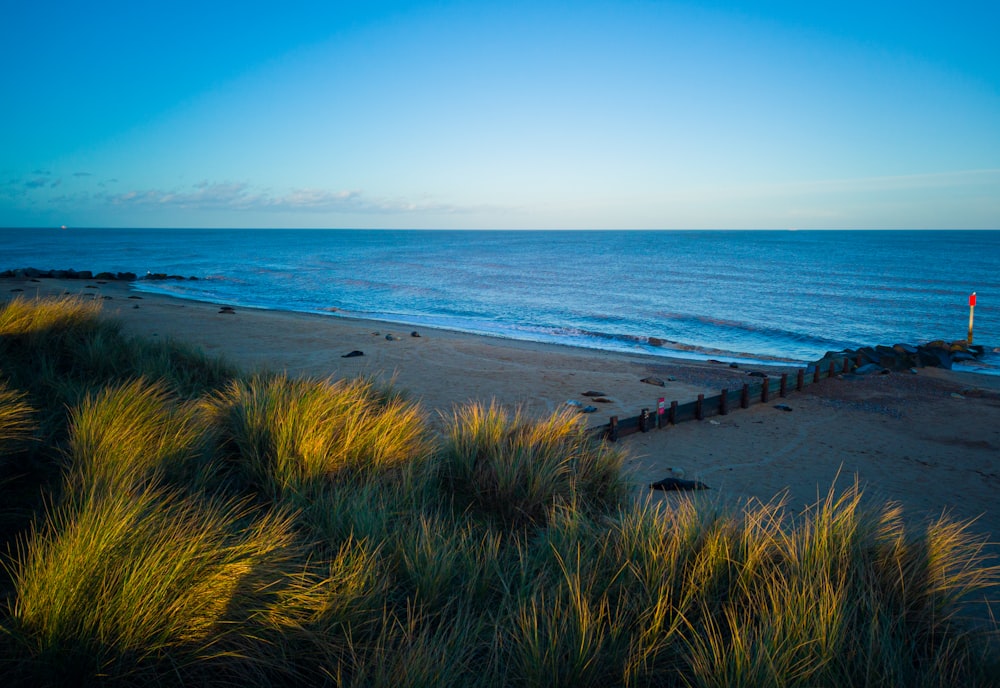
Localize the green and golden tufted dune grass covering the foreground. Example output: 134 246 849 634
0 299 1000 688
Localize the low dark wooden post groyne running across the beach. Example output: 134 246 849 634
593 355 860 442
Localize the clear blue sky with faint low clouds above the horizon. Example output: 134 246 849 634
0 0 1000 229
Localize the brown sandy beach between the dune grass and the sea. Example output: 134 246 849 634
7 279 1000 539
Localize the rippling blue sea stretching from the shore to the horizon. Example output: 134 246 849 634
0 228 1000 374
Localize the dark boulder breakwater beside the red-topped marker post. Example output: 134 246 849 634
816 339 985 372
